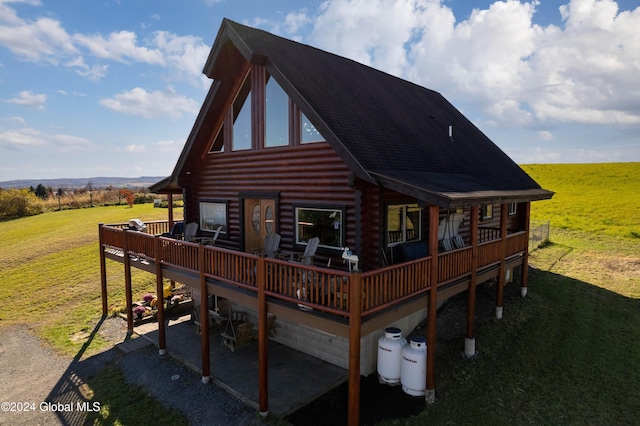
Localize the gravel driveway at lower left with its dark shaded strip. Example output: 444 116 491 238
0 318 266 425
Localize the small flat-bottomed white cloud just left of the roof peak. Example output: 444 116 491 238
100 87 200 119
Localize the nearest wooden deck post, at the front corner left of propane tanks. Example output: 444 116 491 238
348 272 362 426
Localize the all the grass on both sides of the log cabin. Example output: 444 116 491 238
0 163 640 424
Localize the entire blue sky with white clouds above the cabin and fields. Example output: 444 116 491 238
0 0 640 181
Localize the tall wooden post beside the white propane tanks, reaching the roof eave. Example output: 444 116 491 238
425 205 440 404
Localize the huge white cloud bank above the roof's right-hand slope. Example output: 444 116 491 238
311 0 640 130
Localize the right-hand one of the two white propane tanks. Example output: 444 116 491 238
400 336 427 396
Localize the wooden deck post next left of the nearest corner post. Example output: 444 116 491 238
256 256 269 417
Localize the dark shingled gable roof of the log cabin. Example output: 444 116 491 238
176 19 552 207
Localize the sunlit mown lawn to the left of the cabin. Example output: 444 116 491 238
0 204 180 355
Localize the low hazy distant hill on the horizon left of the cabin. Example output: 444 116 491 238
0 176 166 190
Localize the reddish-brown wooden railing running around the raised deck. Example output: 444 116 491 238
100 222 528 317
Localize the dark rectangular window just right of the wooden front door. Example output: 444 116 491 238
295 207 344 249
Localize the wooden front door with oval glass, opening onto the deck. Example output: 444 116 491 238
244 198 276 253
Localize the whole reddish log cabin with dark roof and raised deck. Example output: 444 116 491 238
99 19 553 424
